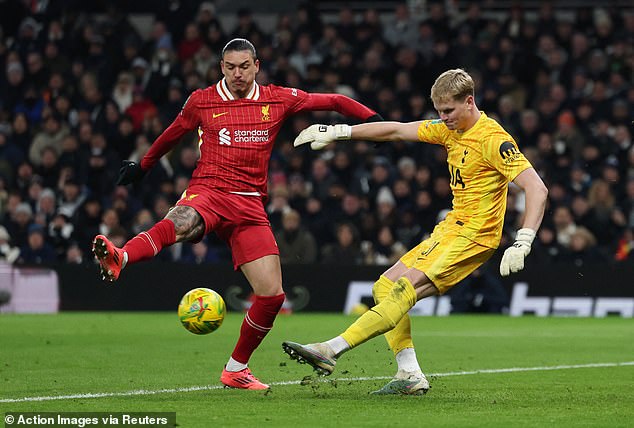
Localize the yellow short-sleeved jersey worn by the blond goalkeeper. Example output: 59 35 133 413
418 112 532 248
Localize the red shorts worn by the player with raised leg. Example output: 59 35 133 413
176 184 280 270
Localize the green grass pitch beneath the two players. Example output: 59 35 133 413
0 312 634 427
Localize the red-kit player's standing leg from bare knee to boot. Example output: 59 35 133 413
220 254 284 389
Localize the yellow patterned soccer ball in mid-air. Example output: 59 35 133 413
178 288 225 334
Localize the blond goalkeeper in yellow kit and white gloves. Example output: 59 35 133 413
282 69 548 394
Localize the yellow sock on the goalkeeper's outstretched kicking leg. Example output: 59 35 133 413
341 278 416 348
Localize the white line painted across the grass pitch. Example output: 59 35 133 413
0 361 634 403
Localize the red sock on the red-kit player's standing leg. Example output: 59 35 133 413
231 293 286 364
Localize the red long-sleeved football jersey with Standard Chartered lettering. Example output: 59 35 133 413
141 79 375 195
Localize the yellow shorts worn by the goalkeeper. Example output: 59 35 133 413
400 221 495 294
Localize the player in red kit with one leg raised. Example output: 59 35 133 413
93 39 381 389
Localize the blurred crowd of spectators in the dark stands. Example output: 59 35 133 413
0 0 634 265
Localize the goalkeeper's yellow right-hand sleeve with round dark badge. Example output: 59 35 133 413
482 133 532 181
